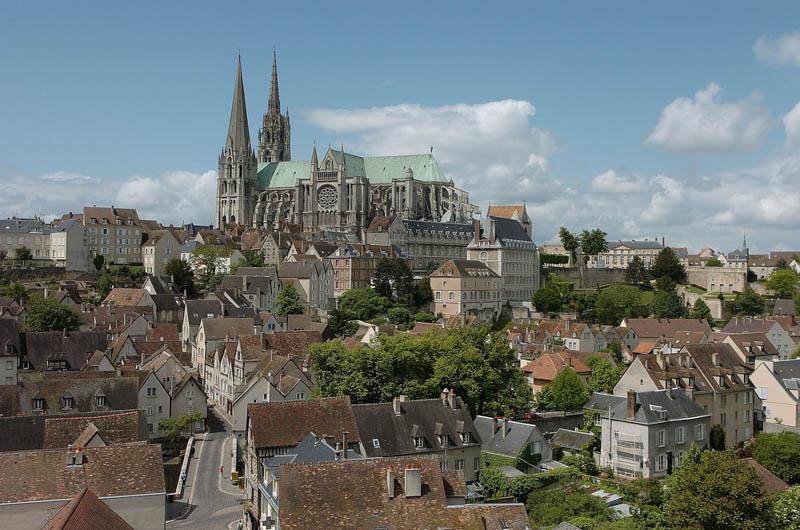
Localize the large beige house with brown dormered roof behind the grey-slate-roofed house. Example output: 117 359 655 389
614 343 756 445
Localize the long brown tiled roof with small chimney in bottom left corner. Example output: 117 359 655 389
0 443 165 503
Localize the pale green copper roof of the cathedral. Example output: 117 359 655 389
258 150 450 189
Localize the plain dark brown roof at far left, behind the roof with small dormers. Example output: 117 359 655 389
21 331 108 370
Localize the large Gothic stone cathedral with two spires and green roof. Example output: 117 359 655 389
216 52 479 237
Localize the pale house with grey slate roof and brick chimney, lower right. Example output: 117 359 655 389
586 387 711 478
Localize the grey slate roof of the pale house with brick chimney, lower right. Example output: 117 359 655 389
585 389 710 425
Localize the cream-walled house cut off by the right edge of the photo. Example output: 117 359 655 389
750 359 800 430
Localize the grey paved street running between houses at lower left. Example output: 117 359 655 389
167 409 242 530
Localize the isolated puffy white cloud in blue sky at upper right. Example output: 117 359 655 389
645 83 770 153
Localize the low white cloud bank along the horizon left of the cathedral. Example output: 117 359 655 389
0 171 217 224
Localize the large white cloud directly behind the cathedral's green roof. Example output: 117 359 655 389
305 99 556 201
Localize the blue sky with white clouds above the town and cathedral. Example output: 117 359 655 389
0 1 800 252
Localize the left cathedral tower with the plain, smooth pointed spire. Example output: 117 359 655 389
216 57 258 228
